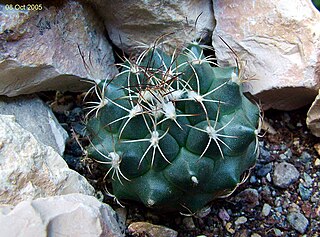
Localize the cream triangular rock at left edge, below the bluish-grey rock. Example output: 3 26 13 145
0 115 94 205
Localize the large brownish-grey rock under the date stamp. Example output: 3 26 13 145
0 0 116 96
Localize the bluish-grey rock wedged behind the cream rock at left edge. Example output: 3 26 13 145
0 95 68 156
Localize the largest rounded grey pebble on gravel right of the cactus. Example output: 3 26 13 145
272 162 300 188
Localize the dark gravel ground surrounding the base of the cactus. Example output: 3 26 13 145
45 94 320 237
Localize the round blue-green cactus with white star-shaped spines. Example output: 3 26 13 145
87 43 259 212
